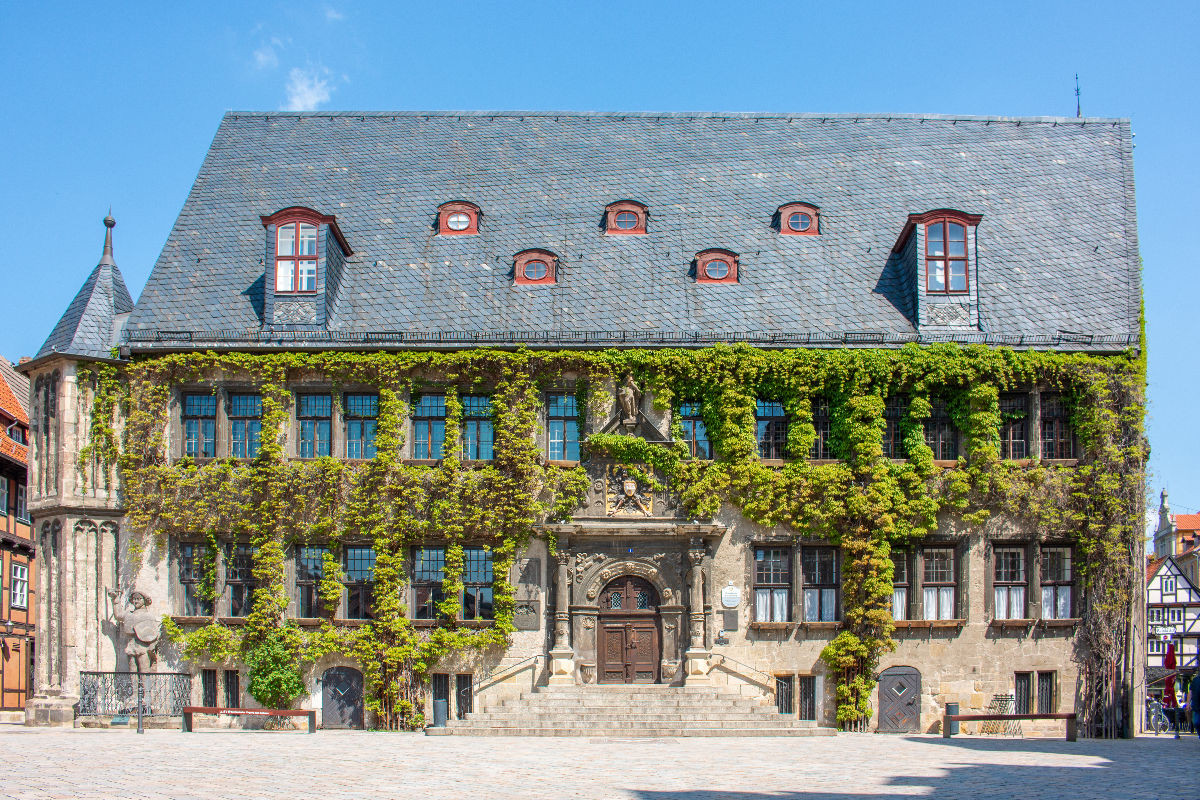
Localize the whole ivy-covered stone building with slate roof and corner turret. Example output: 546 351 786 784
18 114 1146 735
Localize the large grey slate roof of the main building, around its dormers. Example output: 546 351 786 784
121 113 1141 350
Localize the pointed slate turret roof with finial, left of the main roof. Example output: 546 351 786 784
35 217 133 360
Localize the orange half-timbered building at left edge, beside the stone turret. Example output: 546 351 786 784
0 359 37 718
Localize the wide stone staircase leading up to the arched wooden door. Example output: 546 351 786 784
425 685 834 738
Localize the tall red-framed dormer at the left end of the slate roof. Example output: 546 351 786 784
260 206 354 330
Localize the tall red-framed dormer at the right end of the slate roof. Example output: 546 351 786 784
892 209 983 333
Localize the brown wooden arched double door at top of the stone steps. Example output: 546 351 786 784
596 575 662 684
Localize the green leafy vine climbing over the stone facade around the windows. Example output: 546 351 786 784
79 344 1146 728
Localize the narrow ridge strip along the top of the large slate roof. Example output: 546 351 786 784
224 109 1130 125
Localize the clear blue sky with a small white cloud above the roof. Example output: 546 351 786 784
0 0 1200 522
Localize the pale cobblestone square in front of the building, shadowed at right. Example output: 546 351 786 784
0 726 1200 800
